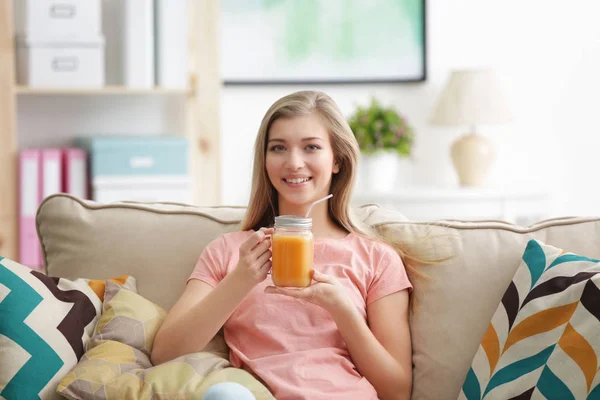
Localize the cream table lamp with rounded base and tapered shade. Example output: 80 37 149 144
431 69 510 186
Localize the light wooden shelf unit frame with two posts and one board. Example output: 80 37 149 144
0 0 222 260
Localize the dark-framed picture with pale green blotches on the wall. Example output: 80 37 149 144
220 0 426 84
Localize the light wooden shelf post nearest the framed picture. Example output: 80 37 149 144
186 0 221 206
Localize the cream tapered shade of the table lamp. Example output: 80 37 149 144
431 69 511 126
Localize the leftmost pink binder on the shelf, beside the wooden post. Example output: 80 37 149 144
19 150 42 269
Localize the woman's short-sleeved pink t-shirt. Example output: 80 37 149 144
190 231 412 400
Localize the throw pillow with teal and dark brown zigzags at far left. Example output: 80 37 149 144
0 257 135 400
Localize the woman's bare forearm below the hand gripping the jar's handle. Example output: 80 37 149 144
152 273 252 364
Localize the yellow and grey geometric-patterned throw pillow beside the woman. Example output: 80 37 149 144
58 282 274 400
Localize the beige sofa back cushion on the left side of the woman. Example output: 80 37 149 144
37 194 244 309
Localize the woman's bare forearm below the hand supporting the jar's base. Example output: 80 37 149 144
332 304 412 400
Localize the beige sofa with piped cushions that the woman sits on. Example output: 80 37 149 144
37 195 600 400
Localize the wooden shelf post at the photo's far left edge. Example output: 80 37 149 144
0 0 18 260
